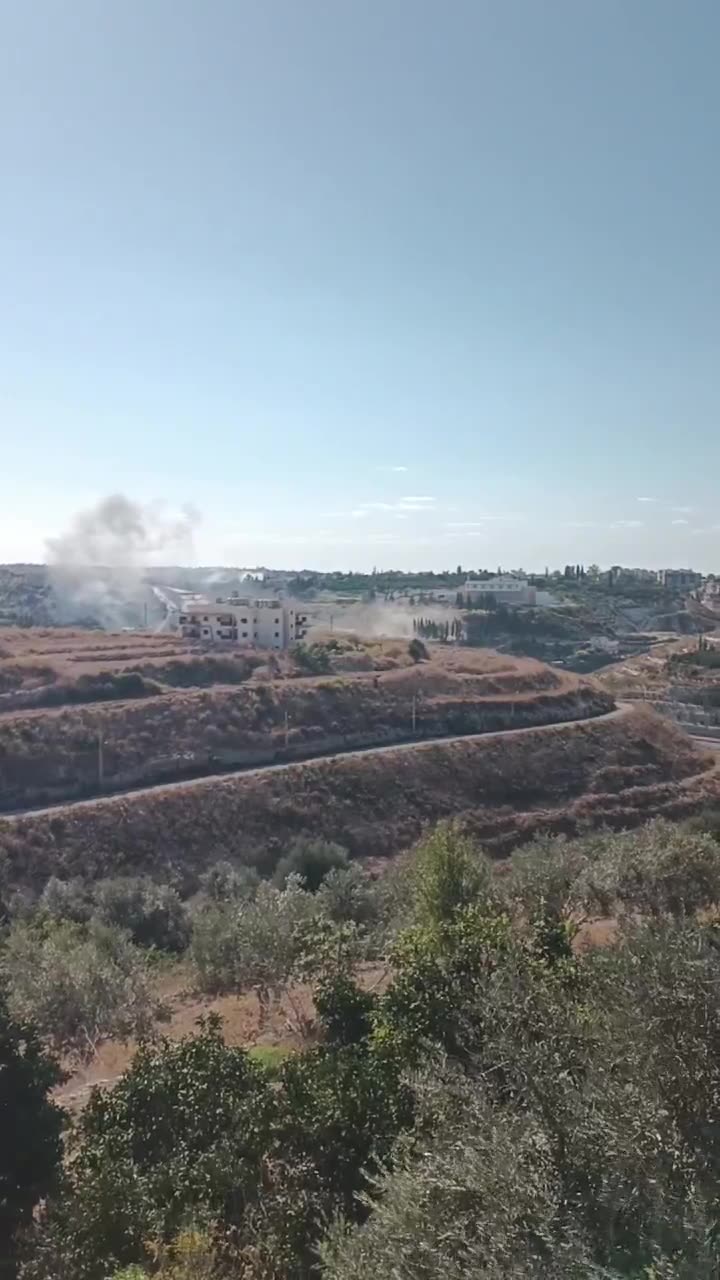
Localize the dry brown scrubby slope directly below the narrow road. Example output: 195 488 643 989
0 708 720 887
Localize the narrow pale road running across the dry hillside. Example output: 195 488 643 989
0 704 634 822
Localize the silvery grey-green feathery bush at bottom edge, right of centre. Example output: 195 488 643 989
323 1080 591 1280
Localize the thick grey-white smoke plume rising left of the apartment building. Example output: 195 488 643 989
46 494 200 630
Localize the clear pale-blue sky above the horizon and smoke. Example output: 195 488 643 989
0 0 720 571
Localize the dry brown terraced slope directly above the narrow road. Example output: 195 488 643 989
0 636 612 810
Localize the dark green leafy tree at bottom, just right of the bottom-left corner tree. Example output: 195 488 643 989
27 1018 277 1280
